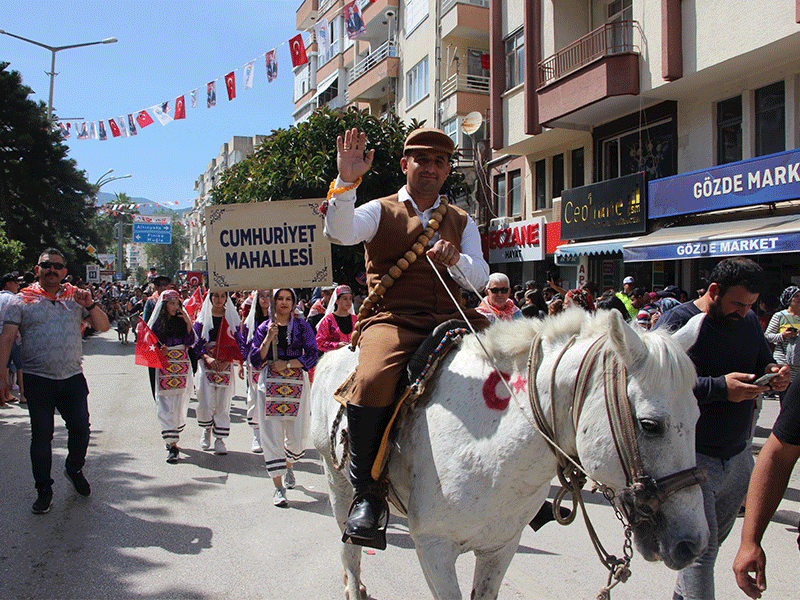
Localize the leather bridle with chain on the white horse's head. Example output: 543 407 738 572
528 334 707 596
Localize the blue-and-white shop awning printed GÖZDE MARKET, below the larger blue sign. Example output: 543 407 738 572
622 215 800 262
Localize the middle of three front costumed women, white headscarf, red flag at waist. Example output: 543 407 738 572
194 292 244 454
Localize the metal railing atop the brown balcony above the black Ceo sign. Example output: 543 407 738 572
539 21 642 88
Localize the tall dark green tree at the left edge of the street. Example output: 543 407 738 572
0 62 97 276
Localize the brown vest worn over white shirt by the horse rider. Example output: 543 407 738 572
364 194 469 314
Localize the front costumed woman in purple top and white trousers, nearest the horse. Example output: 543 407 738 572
249 289 319 506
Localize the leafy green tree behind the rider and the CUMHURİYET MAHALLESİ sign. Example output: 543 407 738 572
211 107 468 284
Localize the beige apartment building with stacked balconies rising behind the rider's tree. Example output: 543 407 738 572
294 0 489 214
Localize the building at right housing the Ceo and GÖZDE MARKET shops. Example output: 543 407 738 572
487 0 800 293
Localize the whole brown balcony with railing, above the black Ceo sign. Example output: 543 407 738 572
537 21 642 126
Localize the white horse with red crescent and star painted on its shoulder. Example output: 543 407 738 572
311 309 708 600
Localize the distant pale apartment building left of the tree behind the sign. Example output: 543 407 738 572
181 135 266 271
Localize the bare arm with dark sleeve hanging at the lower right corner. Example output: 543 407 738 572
733 379 800 598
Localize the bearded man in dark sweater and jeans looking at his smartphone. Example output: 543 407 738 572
654 257 790 600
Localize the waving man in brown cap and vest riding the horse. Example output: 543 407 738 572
325 128 489 547
